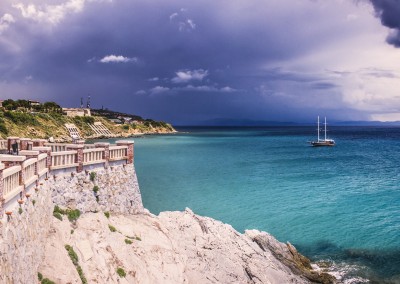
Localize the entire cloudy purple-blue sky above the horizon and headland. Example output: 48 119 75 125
0 0 400 125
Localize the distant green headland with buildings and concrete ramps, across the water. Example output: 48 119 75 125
0 99 176 142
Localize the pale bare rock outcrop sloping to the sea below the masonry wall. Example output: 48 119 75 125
39 209 330 283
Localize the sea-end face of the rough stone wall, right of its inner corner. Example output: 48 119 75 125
48 164 144 214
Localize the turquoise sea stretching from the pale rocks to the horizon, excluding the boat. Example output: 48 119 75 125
130 127 400 283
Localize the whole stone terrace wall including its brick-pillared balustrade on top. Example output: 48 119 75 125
0 137 145 284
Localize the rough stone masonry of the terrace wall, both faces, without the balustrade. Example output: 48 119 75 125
0 164 144 284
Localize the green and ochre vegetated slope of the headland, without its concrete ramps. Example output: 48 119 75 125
0 100 175 141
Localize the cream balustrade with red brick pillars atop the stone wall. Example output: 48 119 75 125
0 137 133 219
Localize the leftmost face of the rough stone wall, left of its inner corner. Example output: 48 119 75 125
0 181 54 284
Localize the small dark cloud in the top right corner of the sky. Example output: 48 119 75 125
370 0 400 47
